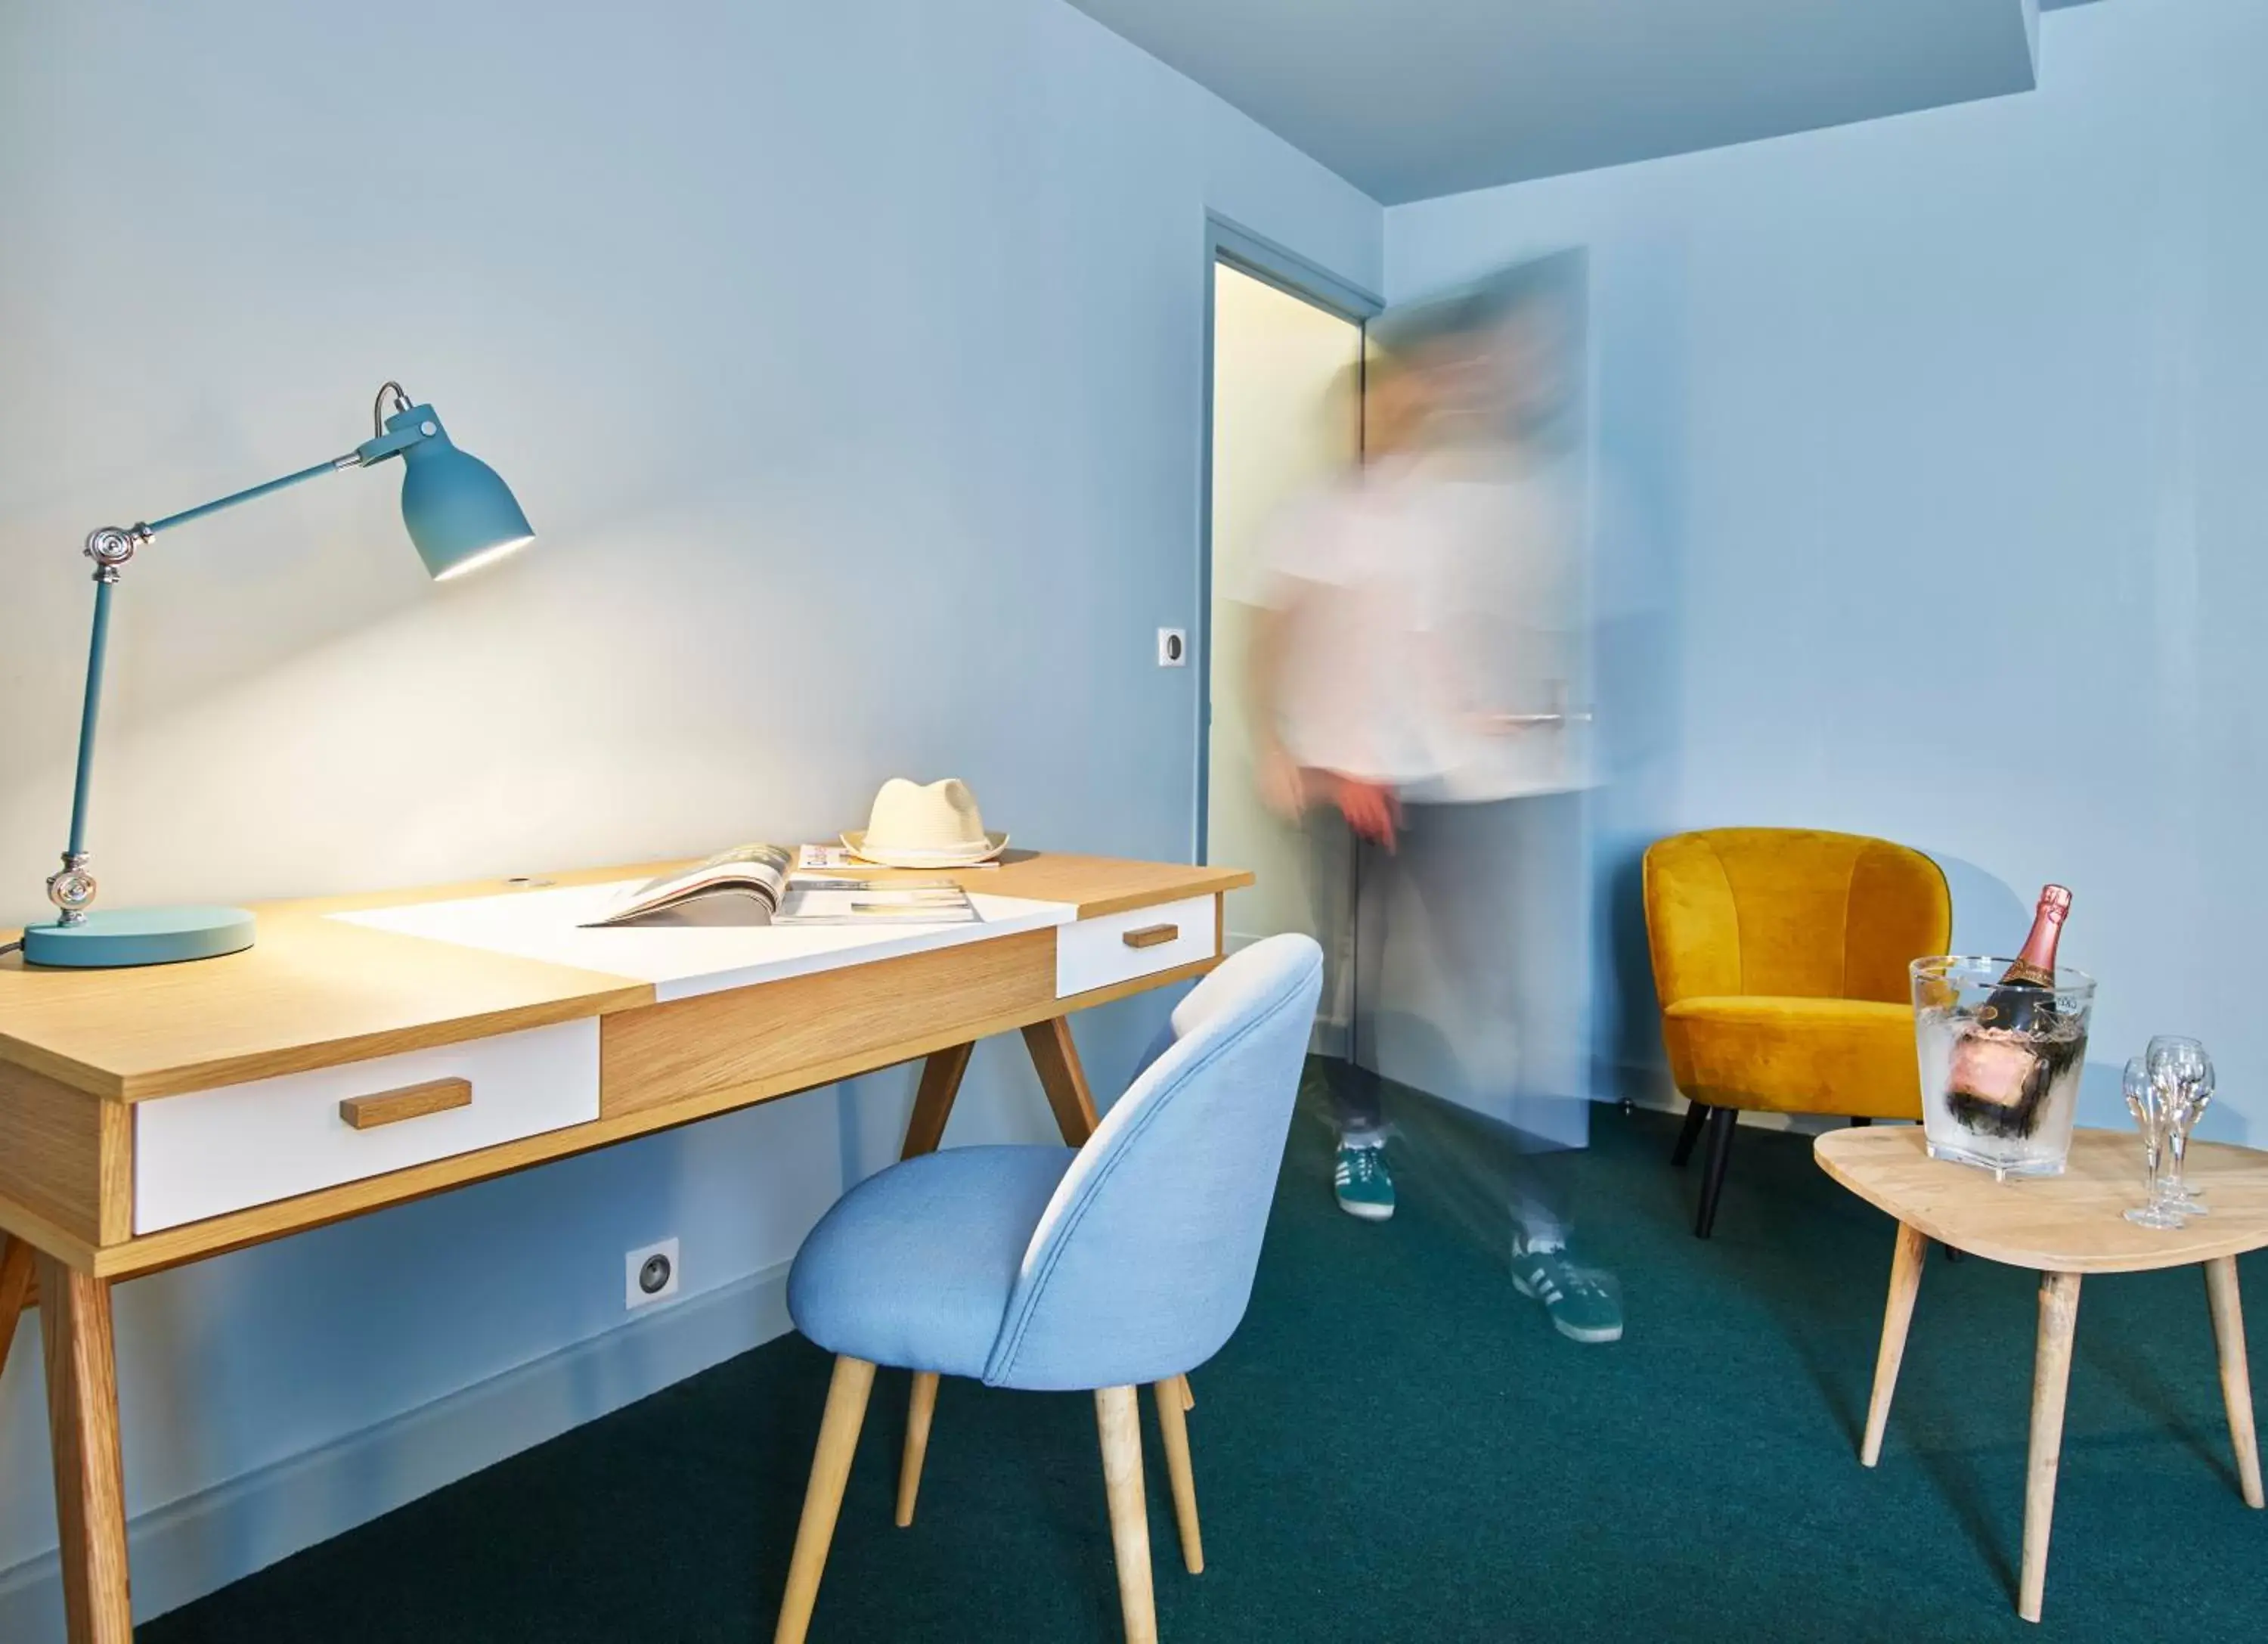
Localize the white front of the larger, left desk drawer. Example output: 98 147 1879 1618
134 1018 599 1233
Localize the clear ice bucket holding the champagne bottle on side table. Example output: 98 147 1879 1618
1910 954 2096 1179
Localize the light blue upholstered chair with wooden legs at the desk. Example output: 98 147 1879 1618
773 936 1322 1644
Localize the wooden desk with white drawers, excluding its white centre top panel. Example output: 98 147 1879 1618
0 852 1252 1644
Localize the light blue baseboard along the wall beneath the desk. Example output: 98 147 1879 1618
0 1261 789 1639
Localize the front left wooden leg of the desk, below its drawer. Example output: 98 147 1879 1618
39 1256 134 1644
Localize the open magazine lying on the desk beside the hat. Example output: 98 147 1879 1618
583 845 978 929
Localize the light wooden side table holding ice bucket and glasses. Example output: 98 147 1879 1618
1812 1127 2268 1621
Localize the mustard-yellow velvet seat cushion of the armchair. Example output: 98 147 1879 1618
1662 995 1921 1118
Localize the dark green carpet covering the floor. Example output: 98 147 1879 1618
141 1084 2268 1644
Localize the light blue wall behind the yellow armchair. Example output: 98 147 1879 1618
1388 0 2268 1138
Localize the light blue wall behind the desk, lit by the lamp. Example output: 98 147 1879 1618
0 0 1381 1637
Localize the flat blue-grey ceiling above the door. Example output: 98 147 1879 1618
1070 0 2082 204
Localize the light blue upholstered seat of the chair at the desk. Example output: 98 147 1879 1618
787 1147 1077 1376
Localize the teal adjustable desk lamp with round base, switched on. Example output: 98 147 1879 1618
23 383 535 968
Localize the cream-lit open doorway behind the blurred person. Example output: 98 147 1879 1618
1198 225 1377 1056
